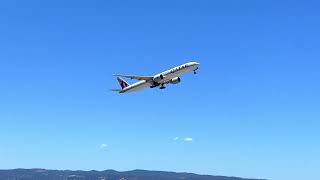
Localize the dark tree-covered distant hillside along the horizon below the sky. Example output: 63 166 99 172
0 169 264 180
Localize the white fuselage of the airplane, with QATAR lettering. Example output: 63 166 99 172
120 62 200 93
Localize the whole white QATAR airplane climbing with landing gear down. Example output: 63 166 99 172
112 62 200 93
